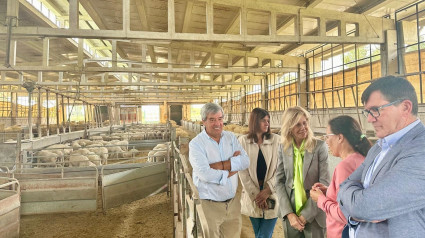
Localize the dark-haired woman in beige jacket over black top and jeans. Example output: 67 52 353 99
238 108 280 237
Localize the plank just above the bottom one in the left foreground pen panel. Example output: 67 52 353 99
21 187 97 203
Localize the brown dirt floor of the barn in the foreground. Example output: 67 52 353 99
20 193 283 238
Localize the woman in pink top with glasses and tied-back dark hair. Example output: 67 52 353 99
310 116 372 238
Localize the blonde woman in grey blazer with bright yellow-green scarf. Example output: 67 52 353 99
276 106 329 238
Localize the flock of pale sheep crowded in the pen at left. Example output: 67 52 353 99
30 130 169 167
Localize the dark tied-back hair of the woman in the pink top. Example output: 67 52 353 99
328 116 372 156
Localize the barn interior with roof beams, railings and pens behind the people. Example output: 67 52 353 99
0 0 425 237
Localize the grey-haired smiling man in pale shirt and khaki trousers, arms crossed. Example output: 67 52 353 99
189 103 249 238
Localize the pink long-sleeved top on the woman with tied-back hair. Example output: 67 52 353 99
317 153 364 238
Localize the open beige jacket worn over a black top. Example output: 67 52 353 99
238 134 281 219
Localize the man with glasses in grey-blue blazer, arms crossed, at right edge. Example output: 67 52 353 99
338 76 425 238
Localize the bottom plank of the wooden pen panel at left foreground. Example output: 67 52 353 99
21 200 97 215
